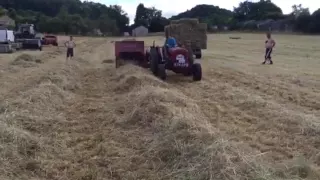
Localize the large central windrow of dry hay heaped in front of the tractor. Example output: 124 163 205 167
96 65 318 180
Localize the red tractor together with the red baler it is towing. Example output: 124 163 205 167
115 39 202 81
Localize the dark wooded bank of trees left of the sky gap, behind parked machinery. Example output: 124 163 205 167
0 0 129 34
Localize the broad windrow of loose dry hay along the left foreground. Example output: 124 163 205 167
0 63 80 179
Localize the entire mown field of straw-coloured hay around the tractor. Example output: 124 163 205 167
0 34 320 180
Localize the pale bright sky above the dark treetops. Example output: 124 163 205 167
87 0 320 23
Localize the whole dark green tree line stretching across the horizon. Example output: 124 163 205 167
0 0 320 35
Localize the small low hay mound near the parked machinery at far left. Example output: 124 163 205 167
11 54 43 68
